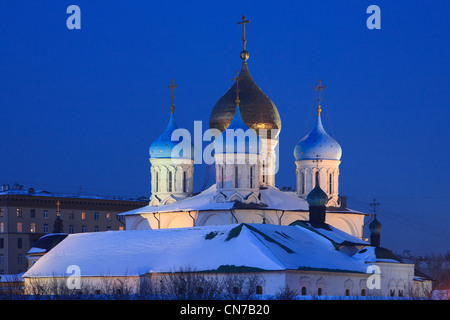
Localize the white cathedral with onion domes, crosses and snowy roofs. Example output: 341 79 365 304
23 16 431 297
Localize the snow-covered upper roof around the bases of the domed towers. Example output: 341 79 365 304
121 184 363 215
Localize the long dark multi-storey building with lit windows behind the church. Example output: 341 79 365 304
0 184 148 275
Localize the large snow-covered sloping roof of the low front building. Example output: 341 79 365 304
24 224 374 277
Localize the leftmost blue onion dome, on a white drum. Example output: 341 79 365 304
149 112 194 159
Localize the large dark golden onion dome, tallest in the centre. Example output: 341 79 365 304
209 61 281 138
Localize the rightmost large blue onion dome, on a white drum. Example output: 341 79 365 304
294 115 342 161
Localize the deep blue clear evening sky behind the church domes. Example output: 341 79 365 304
0 0 450 254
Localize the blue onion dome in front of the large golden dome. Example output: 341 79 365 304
214 106 261 154
